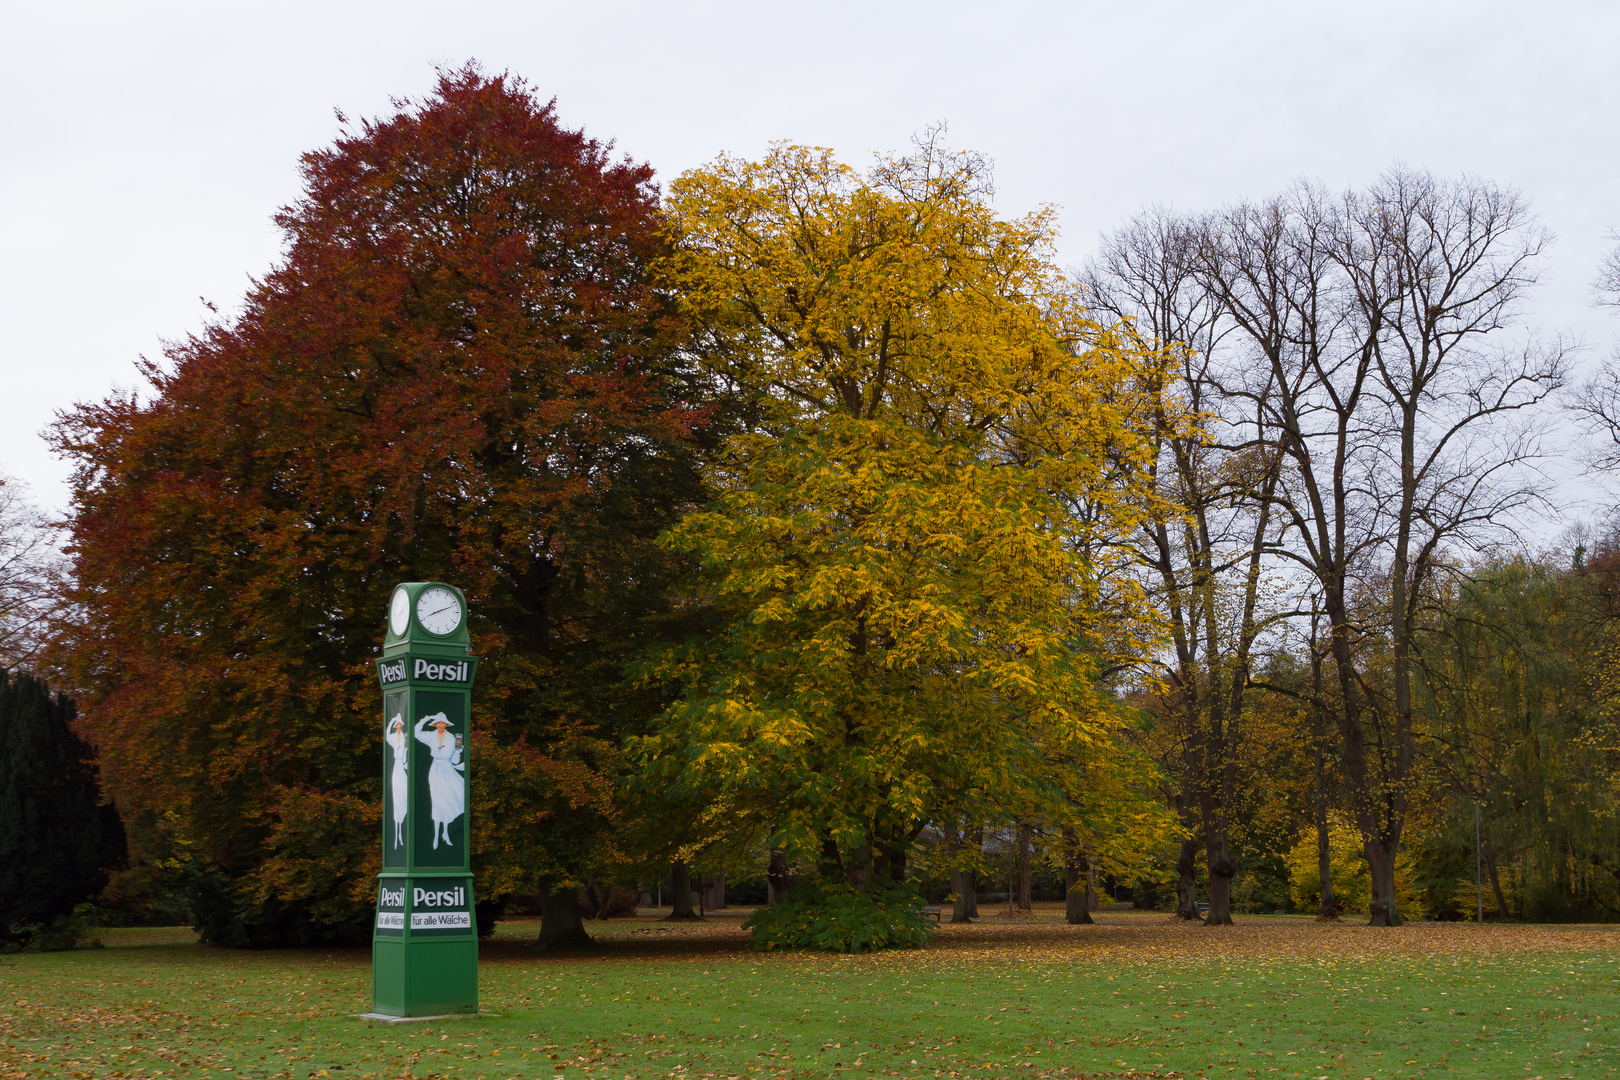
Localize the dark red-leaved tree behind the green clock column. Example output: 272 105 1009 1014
57 66 703 942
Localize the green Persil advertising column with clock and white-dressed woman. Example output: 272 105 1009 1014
371 581 478 1018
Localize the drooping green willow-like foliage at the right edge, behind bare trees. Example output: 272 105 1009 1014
1419 549 1620 920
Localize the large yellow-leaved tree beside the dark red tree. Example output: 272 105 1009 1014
638 139 1165 945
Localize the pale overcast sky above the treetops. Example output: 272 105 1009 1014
0 0 1620 510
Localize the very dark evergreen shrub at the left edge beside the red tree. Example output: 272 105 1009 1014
0 669 123 946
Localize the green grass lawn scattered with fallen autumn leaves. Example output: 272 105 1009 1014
0 905 1620 1080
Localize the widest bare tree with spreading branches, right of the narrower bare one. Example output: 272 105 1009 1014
1202 168 1565 926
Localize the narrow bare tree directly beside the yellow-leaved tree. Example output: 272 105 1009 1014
1081 210 1280 925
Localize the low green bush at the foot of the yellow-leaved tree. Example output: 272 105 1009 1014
744 884 935 952
